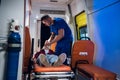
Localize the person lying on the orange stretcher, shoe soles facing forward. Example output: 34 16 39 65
33 46 66 67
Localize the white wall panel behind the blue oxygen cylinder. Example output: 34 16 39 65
0 0 24 80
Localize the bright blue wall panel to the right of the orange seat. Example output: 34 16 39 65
90 0 120 74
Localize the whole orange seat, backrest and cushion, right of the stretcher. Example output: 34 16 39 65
72 40 116 80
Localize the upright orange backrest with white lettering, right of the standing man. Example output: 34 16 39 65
71 40 94 69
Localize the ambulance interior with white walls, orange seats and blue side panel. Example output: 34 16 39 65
0 0 120 80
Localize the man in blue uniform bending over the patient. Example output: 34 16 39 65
41 15 73 65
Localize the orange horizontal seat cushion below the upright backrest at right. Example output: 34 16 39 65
77 64 116 80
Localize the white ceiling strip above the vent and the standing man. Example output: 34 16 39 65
31 0 72 10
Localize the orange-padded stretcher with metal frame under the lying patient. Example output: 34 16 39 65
33 50 74 80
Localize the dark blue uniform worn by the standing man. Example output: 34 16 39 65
50 18 73 57
